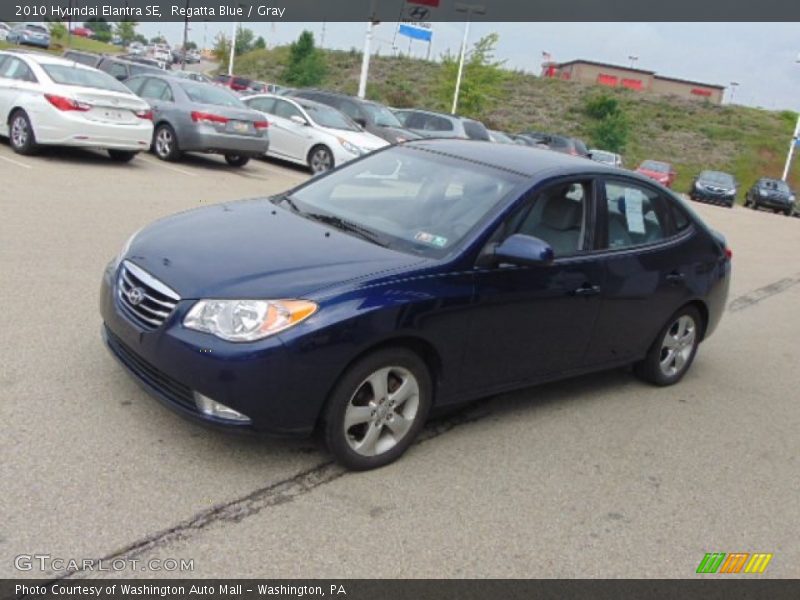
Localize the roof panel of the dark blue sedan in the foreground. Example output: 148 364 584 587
403 138 624 181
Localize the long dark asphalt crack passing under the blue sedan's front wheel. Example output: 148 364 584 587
47 398 491 585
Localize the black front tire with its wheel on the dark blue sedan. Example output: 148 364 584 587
321 348 433 471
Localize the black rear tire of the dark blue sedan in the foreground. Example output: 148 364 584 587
633 306 705 386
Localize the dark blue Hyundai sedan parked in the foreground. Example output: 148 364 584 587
101 140 731 469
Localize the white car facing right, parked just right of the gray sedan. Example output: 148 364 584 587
242 94 389 175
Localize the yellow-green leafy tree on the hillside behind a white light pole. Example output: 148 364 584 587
435 33 507 118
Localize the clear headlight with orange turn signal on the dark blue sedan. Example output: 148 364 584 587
183 300 317 342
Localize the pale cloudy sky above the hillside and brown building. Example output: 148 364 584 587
139 22 800 111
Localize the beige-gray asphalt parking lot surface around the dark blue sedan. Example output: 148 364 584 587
0 141 800 578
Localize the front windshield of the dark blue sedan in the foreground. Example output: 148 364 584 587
284 146 521 257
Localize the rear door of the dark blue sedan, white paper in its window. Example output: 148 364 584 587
587 177 706 366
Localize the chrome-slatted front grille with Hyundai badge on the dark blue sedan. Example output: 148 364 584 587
117 260 181 329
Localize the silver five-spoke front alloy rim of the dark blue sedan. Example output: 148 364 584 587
344 366 420 456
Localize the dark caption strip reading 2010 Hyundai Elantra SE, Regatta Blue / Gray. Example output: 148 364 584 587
0 0 800 22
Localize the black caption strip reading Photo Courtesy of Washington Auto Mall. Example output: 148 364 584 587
0 575 800 600
